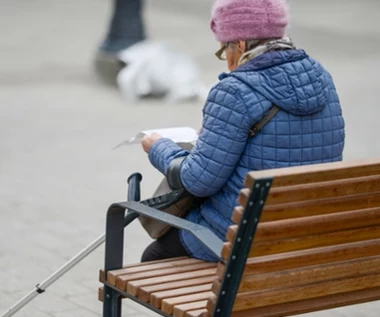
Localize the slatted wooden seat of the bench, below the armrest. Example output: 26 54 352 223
99 257 217 317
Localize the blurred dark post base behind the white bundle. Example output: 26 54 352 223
95 0 145 85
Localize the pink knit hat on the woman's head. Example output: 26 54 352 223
211 0 288 42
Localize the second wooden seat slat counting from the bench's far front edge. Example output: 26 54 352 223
116 260 215 290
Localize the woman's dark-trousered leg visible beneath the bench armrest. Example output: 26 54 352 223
141 229 189 262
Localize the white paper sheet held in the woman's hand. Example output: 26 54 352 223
113 127 198 150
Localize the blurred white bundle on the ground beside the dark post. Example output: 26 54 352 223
117 41 208 102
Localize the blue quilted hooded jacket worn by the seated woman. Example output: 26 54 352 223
149 50 345 261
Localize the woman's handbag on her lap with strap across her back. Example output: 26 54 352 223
139 105 280 239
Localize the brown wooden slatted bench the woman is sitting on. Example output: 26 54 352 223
99 160 380 317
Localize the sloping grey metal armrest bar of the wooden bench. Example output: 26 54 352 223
114 201 224 259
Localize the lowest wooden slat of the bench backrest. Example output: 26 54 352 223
229 288 380 317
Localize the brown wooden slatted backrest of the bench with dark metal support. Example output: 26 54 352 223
207 160 380 317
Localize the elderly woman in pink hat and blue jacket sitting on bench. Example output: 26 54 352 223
142 0 345 261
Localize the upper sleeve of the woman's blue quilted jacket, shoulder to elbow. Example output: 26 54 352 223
181 82 251 197
